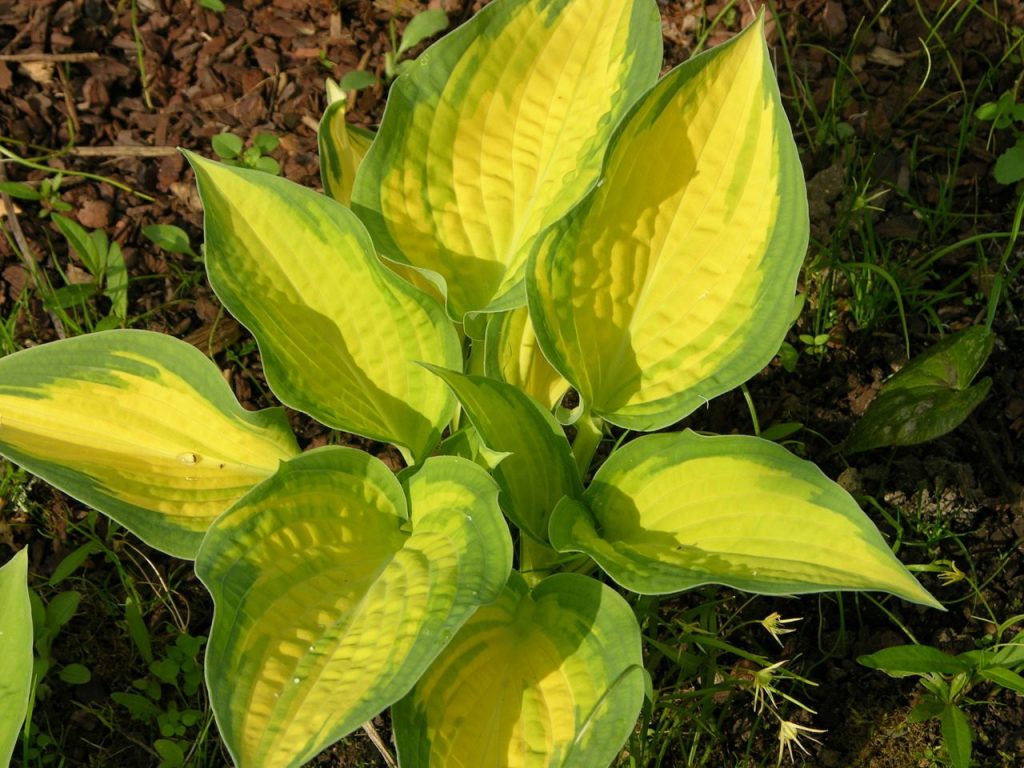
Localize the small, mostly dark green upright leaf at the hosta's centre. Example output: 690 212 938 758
430 367 583 543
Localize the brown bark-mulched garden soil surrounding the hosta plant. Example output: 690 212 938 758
0 0 1024 768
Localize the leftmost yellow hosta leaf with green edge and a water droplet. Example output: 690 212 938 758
0 331 299 558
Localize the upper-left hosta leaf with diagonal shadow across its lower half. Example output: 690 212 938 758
187 154 462 462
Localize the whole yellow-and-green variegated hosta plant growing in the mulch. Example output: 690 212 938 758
0 0 936 768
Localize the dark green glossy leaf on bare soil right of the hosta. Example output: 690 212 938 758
843 326 995 454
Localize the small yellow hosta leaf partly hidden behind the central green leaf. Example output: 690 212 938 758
483 307 569 411
